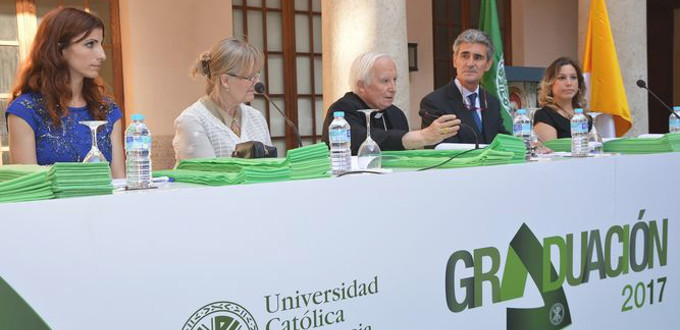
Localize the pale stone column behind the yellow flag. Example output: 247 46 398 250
578 0 649 136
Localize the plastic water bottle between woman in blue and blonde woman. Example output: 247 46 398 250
125 114 151 189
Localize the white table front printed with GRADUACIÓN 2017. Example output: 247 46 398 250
0 153 680 330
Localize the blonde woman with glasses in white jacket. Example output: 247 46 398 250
172 38 272 161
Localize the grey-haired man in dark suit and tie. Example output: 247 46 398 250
419 29 509 144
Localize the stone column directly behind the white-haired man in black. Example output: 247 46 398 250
321 0 417 117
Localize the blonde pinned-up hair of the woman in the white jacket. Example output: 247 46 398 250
191 37 264 95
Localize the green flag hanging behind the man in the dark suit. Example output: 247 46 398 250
479 0 512 133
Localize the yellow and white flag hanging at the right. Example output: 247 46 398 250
583 0 633 137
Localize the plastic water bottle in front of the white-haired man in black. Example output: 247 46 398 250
328 111 352 175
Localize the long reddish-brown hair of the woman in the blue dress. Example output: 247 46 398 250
12 8 110 127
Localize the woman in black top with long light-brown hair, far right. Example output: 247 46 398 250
534 57 592 142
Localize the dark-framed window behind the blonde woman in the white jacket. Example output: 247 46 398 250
232 0 324 155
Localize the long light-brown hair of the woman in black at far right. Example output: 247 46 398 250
538 57 587 111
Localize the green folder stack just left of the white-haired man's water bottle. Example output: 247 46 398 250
286 142 331 180
